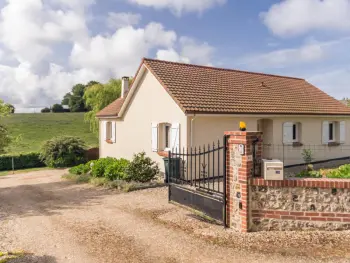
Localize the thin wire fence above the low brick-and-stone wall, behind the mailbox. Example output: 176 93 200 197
262 144 350 166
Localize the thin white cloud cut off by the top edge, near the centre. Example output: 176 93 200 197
128 0 226 16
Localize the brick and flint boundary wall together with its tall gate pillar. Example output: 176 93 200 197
225 131 350 232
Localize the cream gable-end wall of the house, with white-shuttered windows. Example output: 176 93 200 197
100 71 187 171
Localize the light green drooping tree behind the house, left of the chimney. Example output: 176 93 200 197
84 79 121 133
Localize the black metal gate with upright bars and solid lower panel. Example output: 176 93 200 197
168 137 226 227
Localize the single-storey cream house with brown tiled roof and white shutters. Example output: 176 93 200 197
97 59 350 167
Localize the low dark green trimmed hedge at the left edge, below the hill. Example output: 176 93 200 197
0 152 45 171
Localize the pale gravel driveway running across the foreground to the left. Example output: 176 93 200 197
0 170 350 263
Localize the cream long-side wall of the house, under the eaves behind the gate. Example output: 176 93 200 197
188 115 350 165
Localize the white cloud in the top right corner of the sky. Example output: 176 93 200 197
261 0 350 36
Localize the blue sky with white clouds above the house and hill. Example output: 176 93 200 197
0 0 350 112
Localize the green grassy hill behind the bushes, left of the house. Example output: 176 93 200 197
0 113 98 153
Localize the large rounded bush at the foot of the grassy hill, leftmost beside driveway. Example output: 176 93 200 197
40 136 86 168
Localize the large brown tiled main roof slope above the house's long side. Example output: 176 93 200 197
95 59 350 118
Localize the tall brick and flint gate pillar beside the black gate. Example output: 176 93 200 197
225 131 262 232
